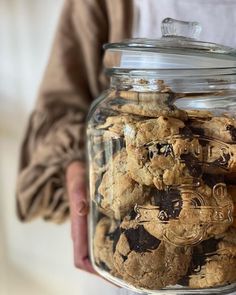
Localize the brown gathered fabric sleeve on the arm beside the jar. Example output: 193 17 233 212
16 0 108 223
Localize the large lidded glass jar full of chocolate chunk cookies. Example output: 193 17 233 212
87 18 236 294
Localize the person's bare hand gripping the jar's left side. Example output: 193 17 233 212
66 162 95 273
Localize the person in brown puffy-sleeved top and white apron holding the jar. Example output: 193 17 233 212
17 0 236 294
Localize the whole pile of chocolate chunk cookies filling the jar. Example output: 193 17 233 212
88 88 236 290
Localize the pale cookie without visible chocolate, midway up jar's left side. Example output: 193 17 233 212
98 149 149 219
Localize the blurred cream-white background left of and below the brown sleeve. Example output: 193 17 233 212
0 0 119 295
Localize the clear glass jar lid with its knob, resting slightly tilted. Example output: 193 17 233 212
104 18 236 70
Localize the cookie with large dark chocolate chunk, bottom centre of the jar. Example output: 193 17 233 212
114 225 191 290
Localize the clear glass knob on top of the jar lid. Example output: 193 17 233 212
161 17 202 39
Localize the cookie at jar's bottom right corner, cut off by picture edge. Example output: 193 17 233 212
182 228 236 288
